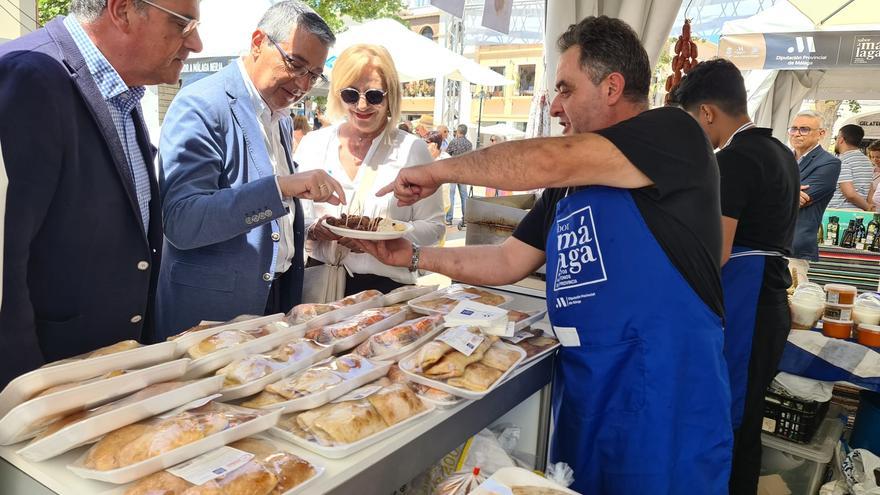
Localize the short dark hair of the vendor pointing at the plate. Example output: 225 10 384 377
556 15 651 103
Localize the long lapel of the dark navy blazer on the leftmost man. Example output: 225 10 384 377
46 18 144 234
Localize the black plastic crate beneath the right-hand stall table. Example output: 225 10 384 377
762 387 830 443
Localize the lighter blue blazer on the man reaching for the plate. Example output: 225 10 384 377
157 63 303 337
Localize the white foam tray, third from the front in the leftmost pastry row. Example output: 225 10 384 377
18 376 223 462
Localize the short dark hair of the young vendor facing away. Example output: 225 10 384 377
672 58 748 116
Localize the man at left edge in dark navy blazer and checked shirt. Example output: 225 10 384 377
0 0 202 386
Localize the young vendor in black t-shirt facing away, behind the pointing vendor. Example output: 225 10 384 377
675 59 800 495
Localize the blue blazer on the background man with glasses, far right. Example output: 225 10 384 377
792 146 840 261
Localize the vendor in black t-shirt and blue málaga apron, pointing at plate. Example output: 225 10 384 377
361 17 733 495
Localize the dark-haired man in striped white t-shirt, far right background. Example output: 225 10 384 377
828 124 874 211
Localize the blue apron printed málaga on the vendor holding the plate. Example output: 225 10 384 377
546 187 733 495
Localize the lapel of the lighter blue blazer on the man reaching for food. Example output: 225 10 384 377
223 62 275 181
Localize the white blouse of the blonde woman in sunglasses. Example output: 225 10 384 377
293 124 446 284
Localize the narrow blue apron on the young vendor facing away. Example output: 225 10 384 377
721 246 782 430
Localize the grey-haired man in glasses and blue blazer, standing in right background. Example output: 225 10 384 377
788 111 840 283
